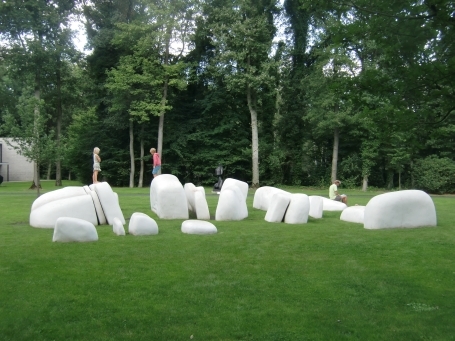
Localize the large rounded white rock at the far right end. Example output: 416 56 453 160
363 190 437 229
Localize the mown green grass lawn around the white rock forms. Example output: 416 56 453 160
0 181 455 341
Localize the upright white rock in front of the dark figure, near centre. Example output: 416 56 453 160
215 185 248 221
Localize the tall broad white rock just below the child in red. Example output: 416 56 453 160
150 174 188 219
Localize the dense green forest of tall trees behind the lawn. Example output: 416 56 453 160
0 0 455 193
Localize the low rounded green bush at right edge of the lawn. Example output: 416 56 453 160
413 155 455 194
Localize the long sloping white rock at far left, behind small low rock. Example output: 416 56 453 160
30 194 98 228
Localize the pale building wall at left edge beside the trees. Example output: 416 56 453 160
0 137 33 182
